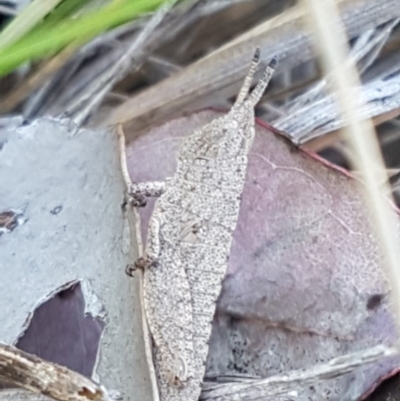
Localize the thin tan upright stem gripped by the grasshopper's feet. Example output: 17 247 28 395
117 124 160 401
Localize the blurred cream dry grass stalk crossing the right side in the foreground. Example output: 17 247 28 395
303 0 400 330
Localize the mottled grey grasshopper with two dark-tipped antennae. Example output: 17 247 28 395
132 52 276 401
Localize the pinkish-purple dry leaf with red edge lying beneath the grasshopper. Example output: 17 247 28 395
128 111 400 401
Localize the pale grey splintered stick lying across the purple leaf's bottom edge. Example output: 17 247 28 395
201 345 398 401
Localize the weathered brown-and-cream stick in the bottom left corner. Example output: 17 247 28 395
0 344 111 401
